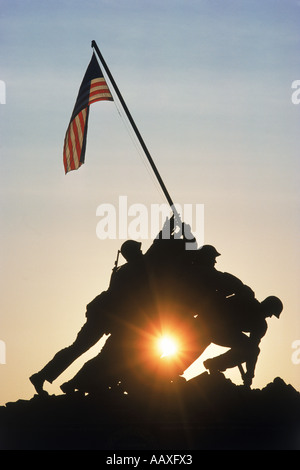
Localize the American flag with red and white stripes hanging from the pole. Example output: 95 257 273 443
63 53 113 173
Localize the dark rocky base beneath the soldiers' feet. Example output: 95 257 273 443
0 372 300 451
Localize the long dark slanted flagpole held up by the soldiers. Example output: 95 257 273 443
92 40 181 223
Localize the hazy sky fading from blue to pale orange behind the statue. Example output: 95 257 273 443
0 0 300 404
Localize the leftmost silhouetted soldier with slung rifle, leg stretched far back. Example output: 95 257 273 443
30 240 148 394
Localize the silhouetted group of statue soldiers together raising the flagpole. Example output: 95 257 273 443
30 219 283 394
